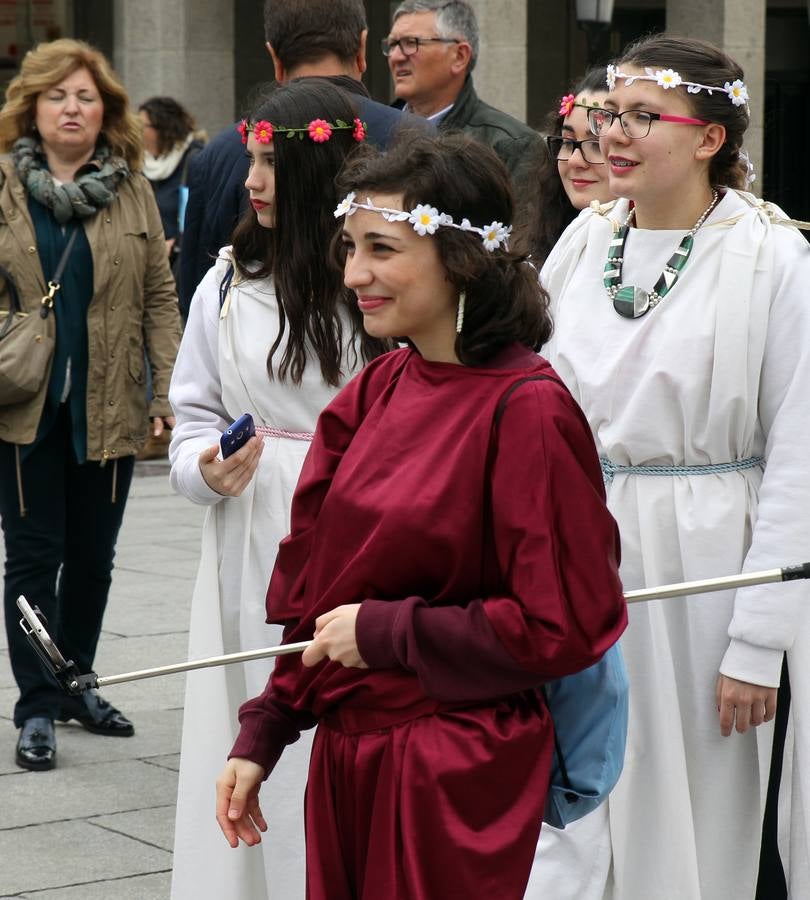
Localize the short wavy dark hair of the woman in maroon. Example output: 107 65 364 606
332 130 551 366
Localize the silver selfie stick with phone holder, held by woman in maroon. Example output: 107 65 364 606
17 562 810 694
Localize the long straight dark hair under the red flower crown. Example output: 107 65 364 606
233 78 390 386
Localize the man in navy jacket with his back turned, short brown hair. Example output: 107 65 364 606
178 0 424 319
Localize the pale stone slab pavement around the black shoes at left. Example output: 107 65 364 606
0 461 204 900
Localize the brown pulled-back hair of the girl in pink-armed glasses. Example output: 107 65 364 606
618 34 750 189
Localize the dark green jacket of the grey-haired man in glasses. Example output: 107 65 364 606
439 75 543 197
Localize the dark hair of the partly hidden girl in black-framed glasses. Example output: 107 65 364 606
517 66 607 265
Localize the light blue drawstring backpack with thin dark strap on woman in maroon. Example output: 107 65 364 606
494 375 629 828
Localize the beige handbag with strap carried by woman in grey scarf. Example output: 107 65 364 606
0 228 78 406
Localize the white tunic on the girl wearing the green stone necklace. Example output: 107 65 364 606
526 191 810 900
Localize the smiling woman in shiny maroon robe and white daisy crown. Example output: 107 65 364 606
217 136 626 900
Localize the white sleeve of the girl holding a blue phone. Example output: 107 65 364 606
169 253 231 506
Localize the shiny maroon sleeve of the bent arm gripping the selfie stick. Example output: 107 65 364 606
357 381 627 701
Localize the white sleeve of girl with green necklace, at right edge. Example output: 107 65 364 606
720 226 810 687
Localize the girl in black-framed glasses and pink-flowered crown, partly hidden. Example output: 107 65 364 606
524 67 615 265
